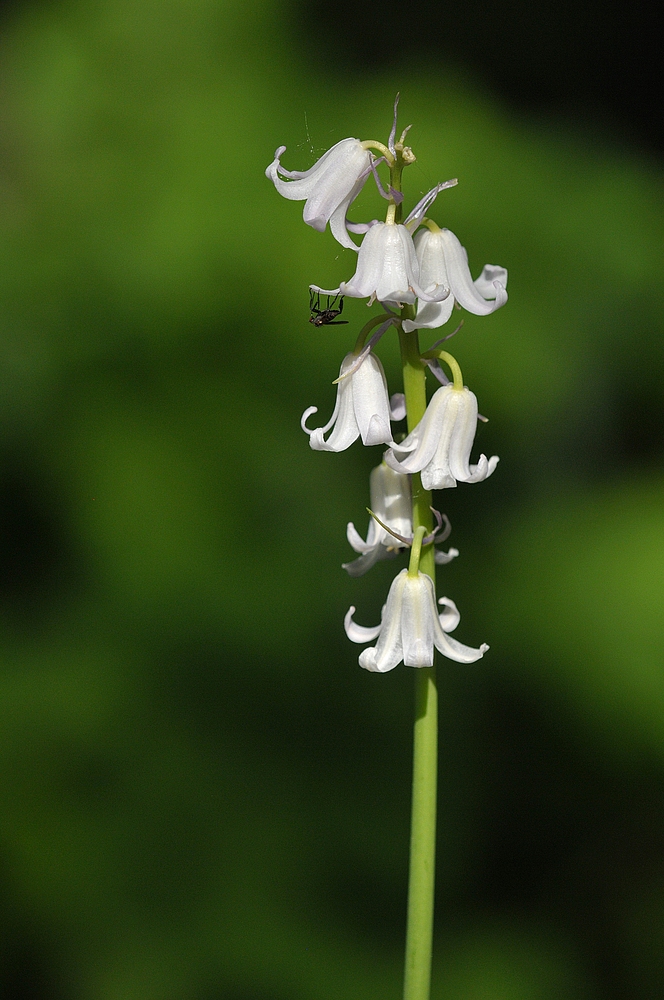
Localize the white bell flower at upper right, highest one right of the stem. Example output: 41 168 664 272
403 227 507 332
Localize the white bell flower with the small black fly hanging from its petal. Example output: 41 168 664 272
336 222 449 305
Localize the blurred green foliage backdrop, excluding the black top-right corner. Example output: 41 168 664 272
0 0 664 1000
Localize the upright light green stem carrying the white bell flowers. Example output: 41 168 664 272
399 318 438 1000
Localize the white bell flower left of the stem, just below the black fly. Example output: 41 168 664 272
300 353 393 451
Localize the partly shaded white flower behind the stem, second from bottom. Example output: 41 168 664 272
343 462 459 576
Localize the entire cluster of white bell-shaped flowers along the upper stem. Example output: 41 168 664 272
266 105 507 673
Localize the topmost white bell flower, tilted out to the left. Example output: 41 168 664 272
265 139 371 251
